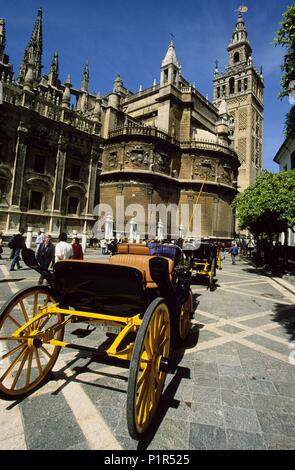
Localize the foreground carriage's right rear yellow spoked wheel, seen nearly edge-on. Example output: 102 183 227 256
127 298 170 439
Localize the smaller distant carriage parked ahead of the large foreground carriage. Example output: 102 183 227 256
183 241 221 291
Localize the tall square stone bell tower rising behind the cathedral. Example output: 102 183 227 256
213 13 264 191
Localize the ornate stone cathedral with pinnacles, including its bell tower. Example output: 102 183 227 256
0 9 263 239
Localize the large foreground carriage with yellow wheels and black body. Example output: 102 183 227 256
0 244 193 439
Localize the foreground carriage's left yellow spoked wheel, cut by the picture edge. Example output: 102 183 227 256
0 286 64 398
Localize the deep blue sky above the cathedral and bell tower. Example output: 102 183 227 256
0 0 292 171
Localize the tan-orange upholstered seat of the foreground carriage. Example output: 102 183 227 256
109 255 174 289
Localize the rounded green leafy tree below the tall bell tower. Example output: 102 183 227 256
232 170 295 239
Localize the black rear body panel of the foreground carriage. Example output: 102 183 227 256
53 260 147 316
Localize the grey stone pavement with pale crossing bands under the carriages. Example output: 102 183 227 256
0 252 295 450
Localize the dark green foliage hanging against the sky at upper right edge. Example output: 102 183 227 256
274 4 295 97
